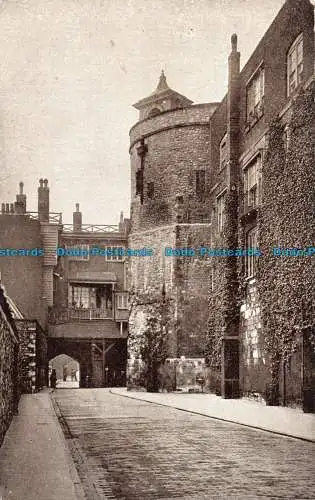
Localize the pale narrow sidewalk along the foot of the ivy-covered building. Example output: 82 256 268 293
111 388 315 442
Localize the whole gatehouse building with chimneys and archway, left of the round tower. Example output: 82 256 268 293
0 183 129 392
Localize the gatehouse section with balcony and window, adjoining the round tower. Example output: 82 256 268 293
48 204 129 387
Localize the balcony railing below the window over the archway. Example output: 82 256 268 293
49 307 113 324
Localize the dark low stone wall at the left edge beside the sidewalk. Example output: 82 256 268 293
0 287 19 444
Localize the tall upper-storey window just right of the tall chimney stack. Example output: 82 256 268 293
246 67 265 124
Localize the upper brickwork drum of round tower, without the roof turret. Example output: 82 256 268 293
130 106 214 232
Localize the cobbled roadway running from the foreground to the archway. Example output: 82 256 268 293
53 389 315 500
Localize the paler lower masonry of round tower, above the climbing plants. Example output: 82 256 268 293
129 224 210 368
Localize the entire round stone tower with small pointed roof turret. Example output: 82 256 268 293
128 71 217 386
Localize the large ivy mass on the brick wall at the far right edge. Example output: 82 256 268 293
257 85 315 403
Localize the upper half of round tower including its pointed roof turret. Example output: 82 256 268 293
130 71 216 231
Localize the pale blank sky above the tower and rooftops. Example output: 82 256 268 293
0 0 284 224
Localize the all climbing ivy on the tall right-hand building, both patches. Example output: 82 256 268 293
206 85 315 404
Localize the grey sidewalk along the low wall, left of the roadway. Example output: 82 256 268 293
0 391 84 500
